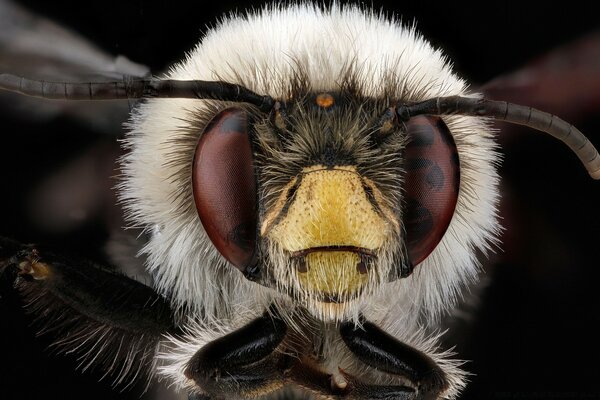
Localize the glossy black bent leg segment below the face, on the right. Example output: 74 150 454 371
340 321 448 400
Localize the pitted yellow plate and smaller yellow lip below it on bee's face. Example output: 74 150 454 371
261 165 393 297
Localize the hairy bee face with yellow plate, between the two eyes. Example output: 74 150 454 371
257 93 405 316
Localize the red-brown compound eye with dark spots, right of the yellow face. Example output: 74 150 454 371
404 116 460 266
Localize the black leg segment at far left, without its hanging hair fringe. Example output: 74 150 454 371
0 238 174 335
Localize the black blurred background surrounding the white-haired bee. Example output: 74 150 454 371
0 0 600 399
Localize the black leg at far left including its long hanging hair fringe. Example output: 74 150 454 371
0 237 176 384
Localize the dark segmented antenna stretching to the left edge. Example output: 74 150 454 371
0 74 275 112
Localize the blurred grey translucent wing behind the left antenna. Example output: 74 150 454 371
0 0 149 134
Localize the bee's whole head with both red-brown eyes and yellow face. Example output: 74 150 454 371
193 90 459 318
